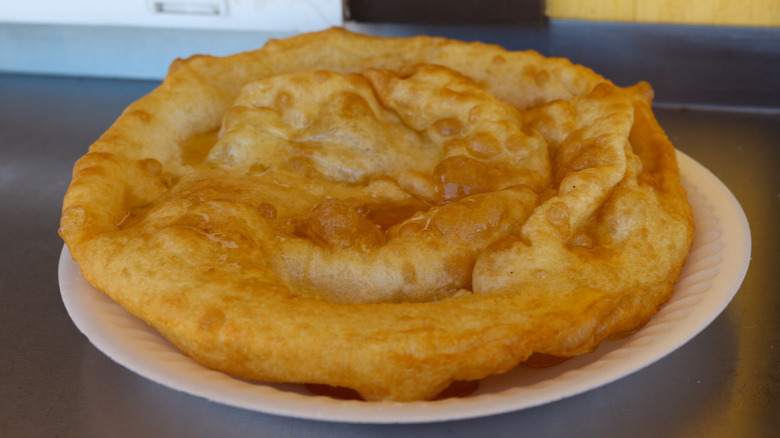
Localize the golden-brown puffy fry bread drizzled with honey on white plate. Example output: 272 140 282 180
60 28 693 401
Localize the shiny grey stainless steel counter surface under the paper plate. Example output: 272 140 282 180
0 44 780 438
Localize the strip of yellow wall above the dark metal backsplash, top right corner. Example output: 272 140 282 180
547 0 780 26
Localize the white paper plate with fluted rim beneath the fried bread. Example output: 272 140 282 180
59 153 751 423
